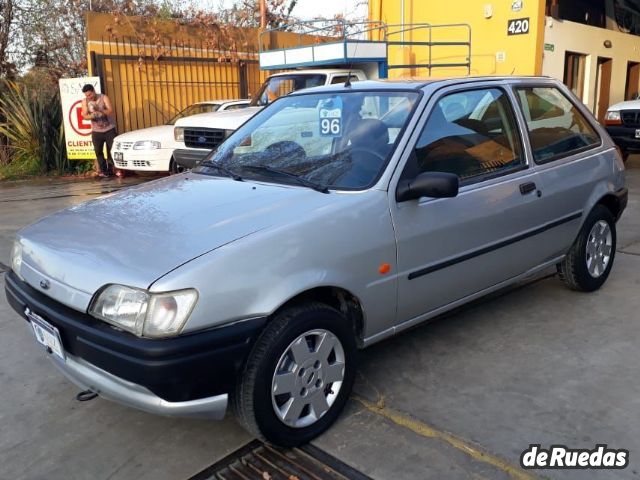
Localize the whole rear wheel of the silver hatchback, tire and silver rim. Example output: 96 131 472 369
558 205 616 292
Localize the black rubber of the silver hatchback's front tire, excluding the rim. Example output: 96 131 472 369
232 302 357 447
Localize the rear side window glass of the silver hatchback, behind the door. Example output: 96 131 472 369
518 87 600 163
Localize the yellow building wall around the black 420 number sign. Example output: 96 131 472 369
369 0 545 77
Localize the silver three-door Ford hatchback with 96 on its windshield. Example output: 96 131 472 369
6 78 627 445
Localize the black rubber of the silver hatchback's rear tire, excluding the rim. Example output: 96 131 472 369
557 205 616 292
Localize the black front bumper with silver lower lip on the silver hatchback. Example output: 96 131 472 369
5 272 266 418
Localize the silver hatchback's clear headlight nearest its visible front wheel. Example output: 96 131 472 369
89 285 198 338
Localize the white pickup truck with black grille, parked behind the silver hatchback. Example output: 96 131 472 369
173 69 367 169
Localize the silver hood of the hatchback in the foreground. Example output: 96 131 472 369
18 173 339 294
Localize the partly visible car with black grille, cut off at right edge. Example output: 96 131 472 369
604 99 640 162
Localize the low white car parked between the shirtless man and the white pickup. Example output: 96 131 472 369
111 100 249 172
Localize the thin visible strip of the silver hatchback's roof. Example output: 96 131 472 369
289 76 558 95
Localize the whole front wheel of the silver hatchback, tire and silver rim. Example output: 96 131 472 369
234 303 356 447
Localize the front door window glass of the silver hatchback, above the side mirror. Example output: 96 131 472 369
416 89 524 182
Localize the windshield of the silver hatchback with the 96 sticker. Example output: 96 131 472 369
193 91 419 191
